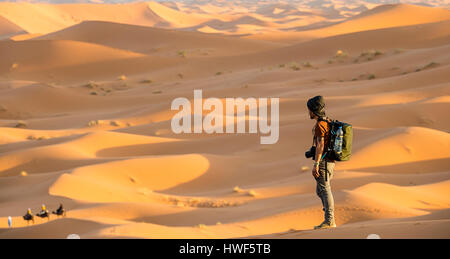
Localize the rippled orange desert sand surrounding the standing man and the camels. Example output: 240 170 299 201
0 1 450 238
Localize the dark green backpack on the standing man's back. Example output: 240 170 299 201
322 119 353 161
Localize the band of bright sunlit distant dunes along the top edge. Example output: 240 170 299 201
0 1 450 42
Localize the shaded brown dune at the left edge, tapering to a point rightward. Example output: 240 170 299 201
0 40 183 83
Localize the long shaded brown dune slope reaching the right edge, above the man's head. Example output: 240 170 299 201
206 21 450 72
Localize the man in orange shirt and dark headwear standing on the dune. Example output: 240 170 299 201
307 96 336 229
